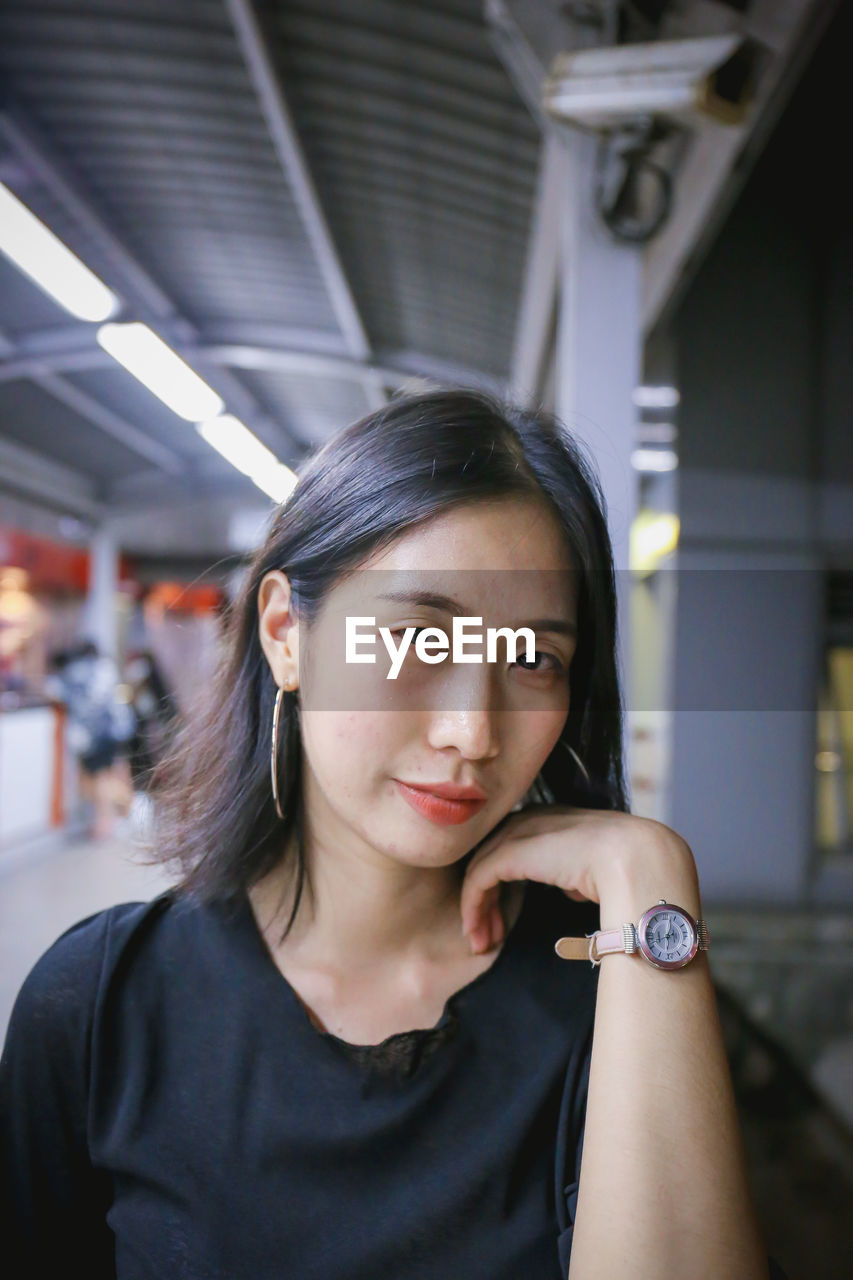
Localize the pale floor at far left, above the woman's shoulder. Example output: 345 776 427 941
0 838 169 1038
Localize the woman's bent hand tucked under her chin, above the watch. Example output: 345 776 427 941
460 805 698 952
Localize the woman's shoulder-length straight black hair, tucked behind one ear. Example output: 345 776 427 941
154 390 628 932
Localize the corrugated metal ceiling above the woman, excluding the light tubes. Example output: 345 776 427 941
0 0 835 553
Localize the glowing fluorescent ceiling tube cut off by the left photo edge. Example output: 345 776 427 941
0 182 119 320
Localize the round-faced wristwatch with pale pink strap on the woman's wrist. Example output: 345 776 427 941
553 899 711 969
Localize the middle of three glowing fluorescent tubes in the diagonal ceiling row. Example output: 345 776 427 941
97 323 225 422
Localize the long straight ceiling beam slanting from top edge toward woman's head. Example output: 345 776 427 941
225 0 386 407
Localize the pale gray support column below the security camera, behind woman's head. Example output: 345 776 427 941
555 133 643 708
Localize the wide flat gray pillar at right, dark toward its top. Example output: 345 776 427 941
672 197 822 904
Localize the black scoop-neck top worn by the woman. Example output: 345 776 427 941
0 882 598 1280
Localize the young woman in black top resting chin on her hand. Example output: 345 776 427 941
0 392 783 1280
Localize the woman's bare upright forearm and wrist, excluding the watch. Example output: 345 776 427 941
569 824 768 1280
